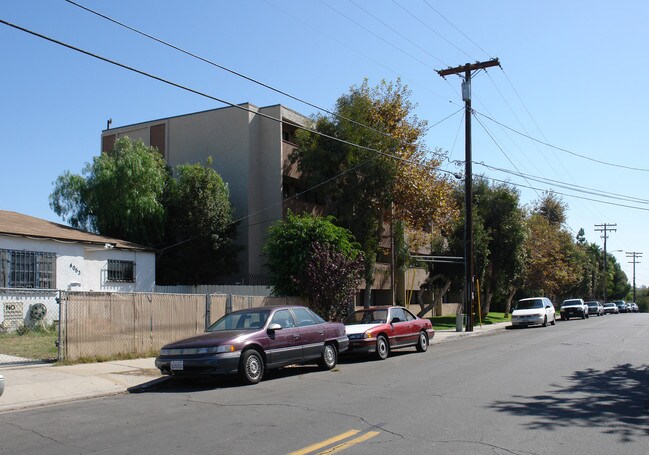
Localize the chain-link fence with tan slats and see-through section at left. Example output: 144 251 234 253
0 289 305 366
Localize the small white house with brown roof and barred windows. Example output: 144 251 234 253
0 210 155 331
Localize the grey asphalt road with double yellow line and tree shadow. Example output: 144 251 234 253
0 314 649 455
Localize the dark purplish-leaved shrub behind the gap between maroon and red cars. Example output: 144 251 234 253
297 241 363 321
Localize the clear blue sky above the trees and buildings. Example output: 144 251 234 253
0 0 649 286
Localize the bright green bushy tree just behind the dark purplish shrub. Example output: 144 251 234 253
263 211 360 296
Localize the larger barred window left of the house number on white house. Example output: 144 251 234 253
0 250 56 289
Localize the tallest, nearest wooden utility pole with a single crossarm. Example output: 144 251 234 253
437 58 500 332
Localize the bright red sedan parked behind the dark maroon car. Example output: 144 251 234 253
343 306 435 360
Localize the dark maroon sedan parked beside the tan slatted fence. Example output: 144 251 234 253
155 306 349 384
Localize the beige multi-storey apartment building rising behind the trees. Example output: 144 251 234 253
101 103 425 304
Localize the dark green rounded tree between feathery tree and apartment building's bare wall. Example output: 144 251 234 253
156 158 239 285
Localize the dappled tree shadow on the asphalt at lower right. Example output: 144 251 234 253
491 364 649 442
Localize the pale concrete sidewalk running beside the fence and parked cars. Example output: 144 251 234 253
0 322 511 413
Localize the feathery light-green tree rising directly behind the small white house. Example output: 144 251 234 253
50 137 169 246
